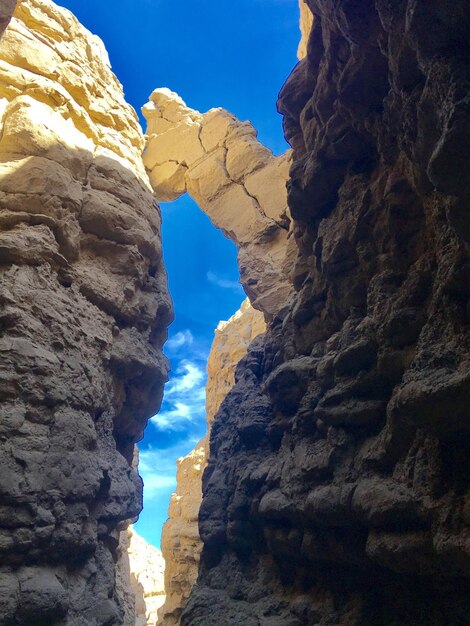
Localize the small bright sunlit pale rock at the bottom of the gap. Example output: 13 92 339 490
119 526 165 626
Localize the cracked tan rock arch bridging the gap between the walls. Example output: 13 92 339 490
142 89 295 314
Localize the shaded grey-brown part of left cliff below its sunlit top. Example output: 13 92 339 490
0 144 172 625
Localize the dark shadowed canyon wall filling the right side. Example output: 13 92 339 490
181 0 470 626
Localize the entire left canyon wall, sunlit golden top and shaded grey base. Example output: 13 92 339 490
0 0 171 626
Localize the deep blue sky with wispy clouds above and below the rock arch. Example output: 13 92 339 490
58 0 300 546
